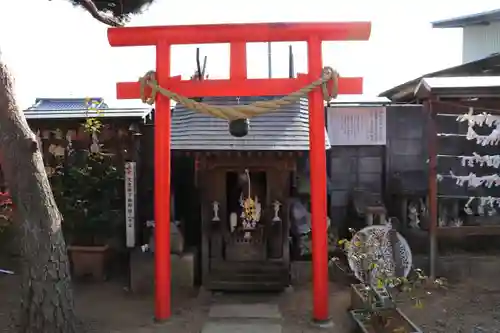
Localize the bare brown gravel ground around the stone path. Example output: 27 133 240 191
0 254 500 333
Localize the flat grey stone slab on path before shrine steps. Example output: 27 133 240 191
208 303 281 319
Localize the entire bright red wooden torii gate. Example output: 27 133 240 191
108 22 371 322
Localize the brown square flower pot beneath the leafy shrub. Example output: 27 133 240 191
68 245 109 281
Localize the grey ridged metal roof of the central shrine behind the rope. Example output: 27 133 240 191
171 97 330 151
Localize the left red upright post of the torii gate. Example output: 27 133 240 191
154 43 171 321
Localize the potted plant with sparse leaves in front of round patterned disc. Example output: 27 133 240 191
332 227 444 333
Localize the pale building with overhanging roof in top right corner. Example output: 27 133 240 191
432 9 500 63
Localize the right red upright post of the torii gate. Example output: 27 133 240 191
307 38 329 321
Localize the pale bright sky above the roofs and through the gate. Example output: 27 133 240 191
0 0 498 108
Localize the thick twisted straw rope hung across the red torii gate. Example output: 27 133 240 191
139 67 339 120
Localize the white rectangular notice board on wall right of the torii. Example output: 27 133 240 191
327 107 386 146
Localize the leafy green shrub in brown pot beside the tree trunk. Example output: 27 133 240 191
50 151 124 279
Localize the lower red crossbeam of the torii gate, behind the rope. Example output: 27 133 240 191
116 76 363 99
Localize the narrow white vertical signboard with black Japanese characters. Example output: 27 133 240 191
125 162 137 247
